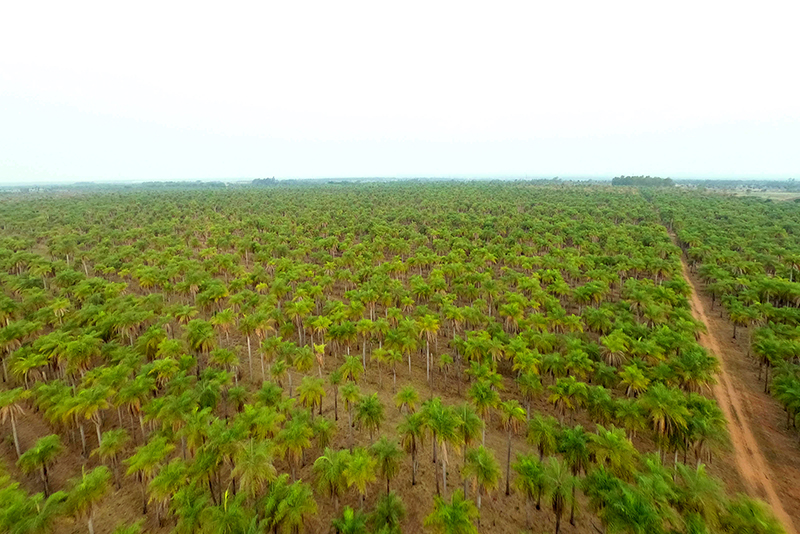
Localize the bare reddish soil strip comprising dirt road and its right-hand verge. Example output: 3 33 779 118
682 262 798 534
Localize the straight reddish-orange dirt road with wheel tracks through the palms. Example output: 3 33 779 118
681 258 797 534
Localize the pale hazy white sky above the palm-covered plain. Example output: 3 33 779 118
0 0 800 183
